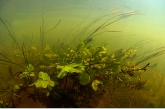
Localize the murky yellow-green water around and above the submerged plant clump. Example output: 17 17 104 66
0 0 165 107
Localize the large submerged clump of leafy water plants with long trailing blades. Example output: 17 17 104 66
0 11 164 107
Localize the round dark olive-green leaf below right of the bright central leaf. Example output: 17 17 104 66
79 73 90 85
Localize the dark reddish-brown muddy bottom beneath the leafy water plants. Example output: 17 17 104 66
9 81 154 108
